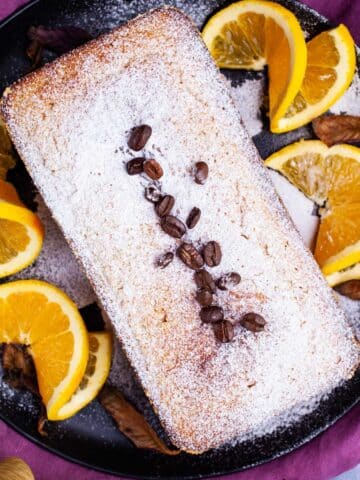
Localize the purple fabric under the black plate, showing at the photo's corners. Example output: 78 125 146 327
0 0 360 480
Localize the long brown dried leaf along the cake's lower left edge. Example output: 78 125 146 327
99 386 180 455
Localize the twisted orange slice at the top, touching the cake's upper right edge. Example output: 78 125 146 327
202 0 307 127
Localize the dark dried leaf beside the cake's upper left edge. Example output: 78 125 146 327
28 25 92 55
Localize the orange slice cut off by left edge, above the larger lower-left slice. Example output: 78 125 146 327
0 179 44 278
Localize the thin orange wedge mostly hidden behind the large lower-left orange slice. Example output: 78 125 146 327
53 332 112 420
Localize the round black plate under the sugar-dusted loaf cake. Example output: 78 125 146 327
0 0 360 479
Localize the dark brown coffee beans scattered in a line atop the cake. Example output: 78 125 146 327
126 125 246 343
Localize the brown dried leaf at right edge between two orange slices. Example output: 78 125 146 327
312 115 360 147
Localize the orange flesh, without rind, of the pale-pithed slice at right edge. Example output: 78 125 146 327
282 153 360 267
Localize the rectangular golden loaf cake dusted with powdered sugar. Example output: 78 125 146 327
1 8 359 453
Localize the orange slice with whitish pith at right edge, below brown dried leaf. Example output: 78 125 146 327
265 140 360 275
